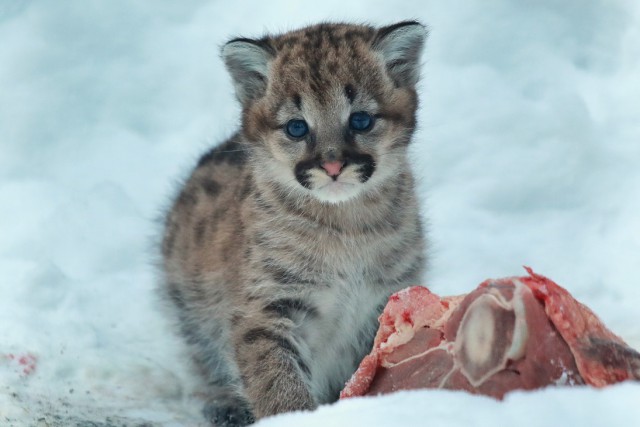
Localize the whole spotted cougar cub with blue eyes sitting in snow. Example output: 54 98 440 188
162 21 426 425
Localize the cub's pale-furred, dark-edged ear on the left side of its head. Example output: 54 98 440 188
222 38 275 106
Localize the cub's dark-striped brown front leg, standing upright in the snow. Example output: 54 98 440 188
233 316 317 418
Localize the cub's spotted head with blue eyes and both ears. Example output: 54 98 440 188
222 21 427 203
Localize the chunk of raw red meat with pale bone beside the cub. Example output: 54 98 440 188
340 268 640 399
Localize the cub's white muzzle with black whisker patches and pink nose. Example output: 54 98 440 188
294 152 376 203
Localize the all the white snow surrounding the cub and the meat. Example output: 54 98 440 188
0 0 640 427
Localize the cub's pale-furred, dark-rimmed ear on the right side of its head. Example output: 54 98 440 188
372 21 428 87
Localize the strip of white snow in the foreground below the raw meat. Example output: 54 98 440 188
258 384 640 427
